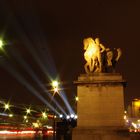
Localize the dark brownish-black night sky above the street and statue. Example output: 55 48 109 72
0 0 140 109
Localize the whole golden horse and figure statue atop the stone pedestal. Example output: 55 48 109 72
83 37 122 74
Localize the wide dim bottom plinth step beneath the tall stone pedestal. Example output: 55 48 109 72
72 127 130 140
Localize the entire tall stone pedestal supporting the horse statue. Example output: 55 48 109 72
72 73 129 140
